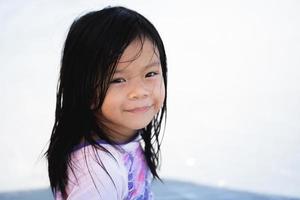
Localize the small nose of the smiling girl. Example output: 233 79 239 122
128 81 150 100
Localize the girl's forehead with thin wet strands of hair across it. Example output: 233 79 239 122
117 39 159 71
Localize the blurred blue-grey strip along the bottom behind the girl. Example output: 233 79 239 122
0 180 300 200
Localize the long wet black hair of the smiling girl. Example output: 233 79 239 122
45 7 167 197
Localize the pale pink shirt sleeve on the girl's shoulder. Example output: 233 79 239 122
63 146 128 200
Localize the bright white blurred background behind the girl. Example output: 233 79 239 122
0 0 300 197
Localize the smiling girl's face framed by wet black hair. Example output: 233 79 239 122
101 39 165 142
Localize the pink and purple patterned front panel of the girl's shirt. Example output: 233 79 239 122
123 145 153 200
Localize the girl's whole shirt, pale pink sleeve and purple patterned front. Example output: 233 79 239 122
55 135 153 200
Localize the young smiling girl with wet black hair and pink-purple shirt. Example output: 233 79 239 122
46 7 167 200
